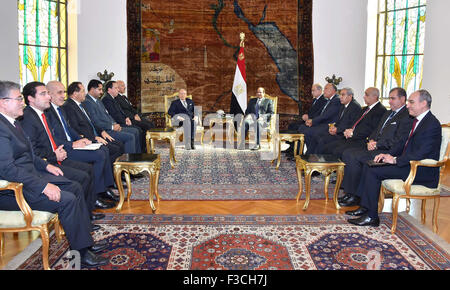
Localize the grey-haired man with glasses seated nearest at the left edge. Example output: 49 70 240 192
0 81 108 267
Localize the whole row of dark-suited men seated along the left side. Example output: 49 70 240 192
0 80 153 266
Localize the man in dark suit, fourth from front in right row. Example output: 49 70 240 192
306 88 361 154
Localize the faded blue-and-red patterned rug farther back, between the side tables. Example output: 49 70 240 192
125 144 340 200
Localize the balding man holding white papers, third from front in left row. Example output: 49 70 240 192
46 81 119 201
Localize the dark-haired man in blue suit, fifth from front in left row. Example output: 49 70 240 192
82 80 141 153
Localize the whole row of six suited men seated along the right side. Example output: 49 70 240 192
287 83 442 226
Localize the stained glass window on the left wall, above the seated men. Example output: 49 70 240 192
17 0 67 85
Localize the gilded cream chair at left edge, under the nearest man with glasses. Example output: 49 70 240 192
0 180 62 270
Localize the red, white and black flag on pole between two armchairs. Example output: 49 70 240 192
230 46 247 115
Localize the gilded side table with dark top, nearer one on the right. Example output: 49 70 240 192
295 154 345 210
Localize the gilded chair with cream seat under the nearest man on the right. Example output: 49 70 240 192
378 127 450 233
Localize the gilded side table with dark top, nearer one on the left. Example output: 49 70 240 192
114 153 161 212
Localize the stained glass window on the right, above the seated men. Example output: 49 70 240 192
375 0 427 99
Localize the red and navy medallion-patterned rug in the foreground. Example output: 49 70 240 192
7 214 450 270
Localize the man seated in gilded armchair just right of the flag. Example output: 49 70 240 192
239 87 274 150
